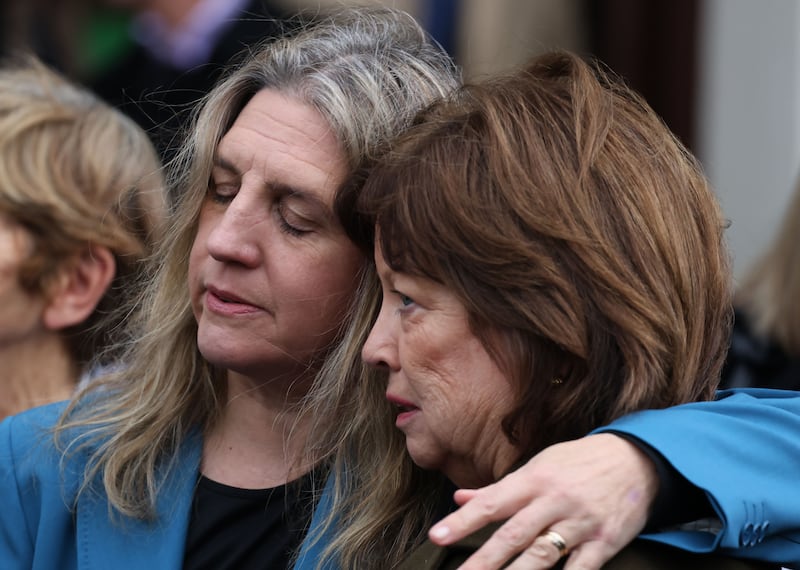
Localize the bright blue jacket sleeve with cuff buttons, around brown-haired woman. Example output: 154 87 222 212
596 389 800 566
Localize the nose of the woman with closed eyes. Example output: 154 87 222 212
206 190 264 267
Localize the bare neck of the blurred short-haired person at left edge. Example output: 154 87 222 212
0 333 79 419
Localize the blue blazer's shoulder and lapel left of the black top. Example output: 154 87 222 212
0 403 202 570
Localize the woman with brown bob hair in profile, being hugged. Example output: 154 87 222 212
304 53 792 568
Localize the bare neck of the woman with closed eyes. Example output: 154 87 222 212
201 372 311 489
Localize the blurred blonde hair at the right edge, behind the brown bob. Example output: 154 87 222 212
736 176 800 355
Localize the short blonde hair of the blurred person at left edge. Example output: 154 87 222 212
0 56 167 365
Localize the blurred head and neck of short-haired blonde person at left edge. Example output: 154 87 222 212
0 58 167 417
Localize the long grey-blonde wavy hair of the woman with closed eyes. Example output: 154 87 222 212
56 3 459 519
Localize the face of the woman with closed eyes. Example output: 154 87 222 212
193 90 360 386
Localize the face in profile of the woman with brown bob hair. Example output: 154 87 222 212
363 245 518 487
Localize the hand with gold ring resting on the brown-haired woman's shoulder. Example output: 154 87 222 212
429 434 658 570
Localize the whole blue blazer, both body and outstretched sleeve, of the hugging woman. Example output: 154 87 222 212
6 390 800 570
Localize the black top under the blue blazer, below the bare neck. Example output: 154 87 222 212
183 474 319 570
